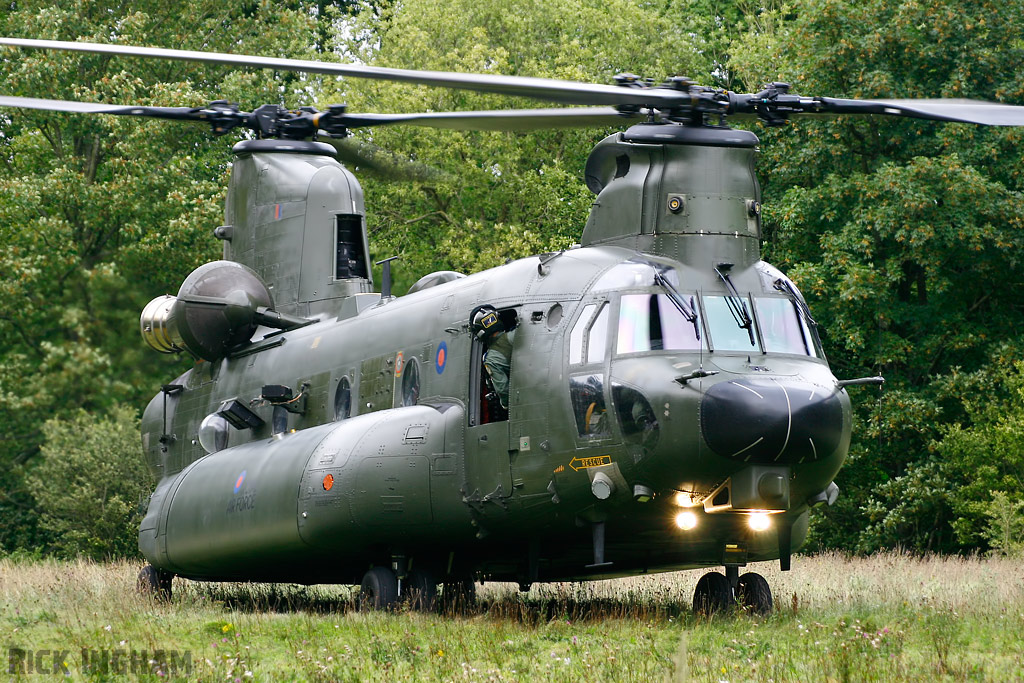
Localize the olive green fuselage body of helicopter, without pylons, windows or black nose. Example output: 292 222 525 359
140 247 849 583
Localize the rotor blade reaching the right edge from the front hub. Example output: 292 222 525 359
819 97 1024 126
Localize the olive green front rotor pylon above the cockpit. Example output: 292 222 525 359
581 124 761 269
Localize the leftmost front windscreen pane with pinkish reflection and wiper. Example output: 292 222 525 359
615 294 700 353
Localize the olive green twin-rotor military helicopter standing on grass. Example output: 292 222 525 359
0 38 1024 611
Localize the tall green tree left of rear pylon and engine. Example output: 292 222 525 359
0 0 312 548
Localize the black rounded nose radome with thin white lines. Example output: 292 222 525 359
700 378 843 463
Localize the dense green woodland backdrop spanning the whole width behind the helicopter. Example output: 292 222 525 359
0 0 1024 552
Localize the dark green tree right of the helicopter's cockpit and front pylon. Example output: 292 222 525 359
733 0 1024 550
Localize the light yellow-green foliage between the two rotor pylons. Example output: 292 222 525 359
324 0 712 288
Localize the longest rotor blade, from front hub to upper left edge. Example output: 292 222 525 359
0 38 690 109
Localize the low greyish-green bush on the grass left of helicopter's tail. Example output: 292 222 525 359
27 405 153 560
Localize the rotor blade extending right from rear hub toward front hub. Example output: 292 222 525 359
344 106 635 131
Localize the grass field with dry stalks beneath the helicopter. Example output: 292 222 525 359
0 554 1024 682
